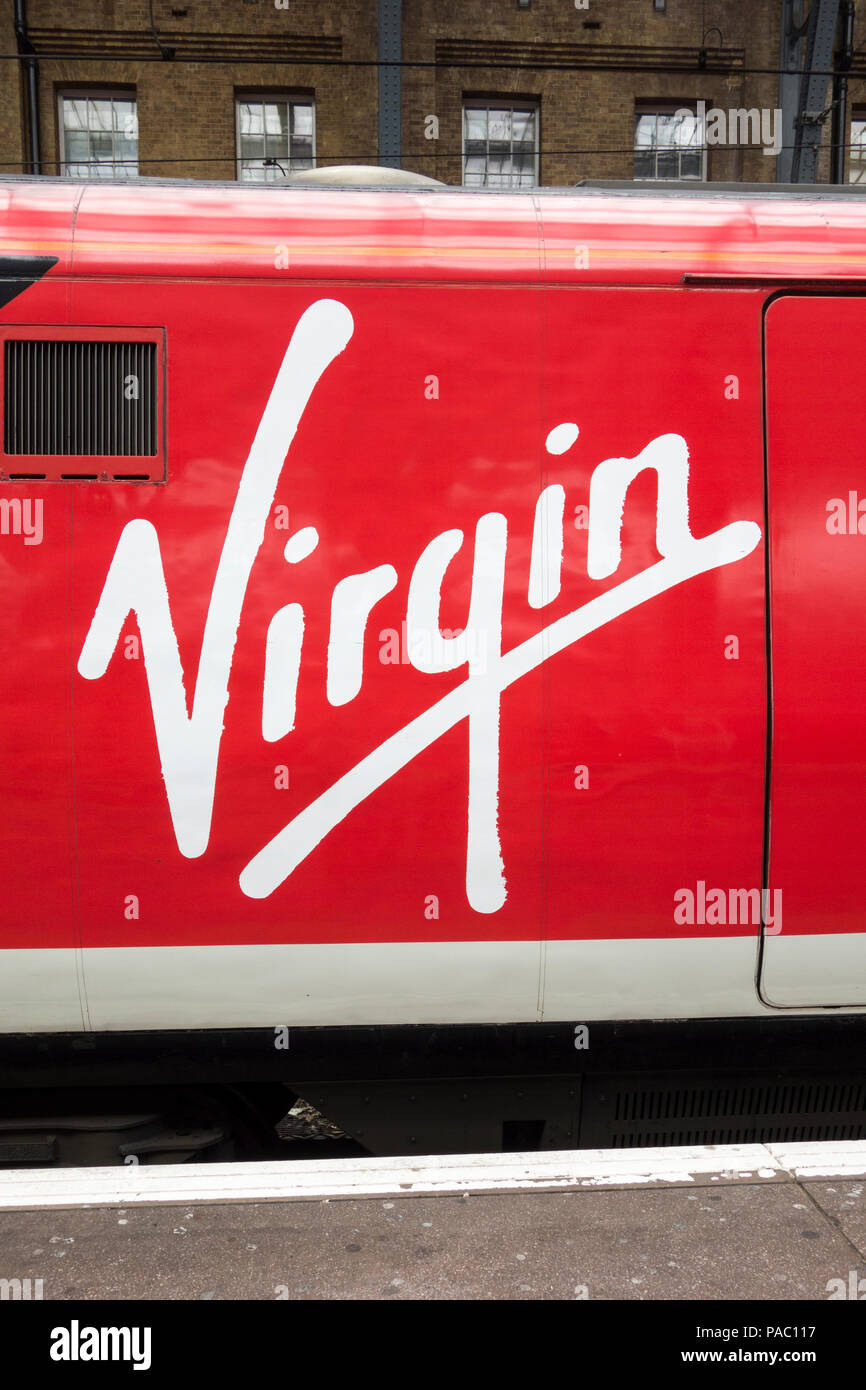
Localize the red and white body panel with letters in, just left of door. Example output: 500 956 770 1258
542 284 766 1020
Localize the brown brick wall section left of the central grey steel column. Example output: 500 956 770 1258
8 0 378 179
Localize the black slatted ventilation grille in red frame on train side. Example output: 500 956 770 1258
3 339 157 458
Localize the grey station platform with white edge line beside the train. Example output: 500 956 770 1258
0 1141 866 1301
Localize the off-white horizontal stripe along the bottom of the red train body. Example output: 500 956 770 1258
0 934 866 1033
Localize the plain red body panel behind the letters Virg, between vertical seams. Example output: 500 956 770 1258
66 282 542 945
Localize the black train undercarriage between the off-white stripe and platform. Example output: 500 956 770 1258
0 1015 866 1168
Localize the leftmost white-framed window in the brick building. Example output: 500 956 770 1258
58 92 139 178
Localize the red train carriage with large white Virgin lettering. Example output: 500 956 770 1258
0 179 866 1147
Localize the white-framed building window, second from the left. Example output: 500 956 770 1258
235 96 316 183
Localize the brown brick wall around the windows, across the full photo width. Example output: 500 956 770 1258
0 0 866 185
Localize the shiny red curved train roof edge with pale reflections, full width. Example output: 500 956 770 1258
0 171 866 286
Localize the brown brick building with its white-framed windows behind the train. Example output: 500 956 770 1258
0 0 866 186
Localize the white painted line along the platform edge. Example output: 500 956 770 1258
0 1140 866 1211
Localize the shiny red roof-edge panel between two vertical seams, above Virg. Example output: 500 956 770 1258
69 186 539 282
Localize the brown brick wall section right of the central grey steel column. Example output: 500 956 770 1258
403 0 780 185
